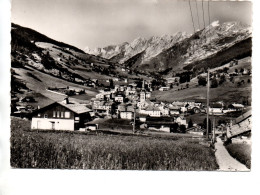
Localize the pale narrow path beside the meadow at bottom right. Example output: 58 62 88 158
215 137 250 171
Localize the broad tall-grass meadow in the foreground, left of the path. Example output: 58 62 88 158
11 118 218 170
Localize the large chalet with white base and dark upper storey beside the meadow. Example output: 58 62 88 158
31 98 91 131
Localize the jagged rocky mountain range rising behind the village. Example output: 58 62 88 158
88 21 252 78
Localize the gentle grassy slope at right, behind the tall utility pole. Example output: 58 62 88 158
152 57 252 105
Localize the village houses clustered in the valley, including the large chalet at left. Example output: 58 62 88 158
26 78 248 132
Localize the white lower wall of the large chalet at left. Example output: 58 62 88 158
31 118 74 131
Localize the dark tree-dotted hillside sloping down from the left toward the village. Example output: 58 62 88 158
11 23 153 105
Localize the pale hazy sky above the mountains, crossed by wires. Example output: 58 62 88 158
11 0 252 49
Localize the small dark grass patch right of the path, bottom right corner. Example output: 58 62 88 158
226 143 251 169
